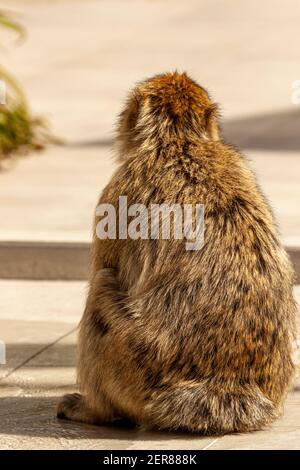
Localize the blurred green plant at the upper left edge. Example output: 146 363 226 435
0 11 51 161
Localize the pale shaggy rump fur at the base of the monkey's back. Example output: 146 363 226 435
146 380 278 435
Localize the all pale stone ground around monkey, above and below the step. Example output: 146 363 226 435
0 0 300 449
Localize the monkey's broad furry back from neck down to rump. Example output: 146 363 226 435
95 142 295 418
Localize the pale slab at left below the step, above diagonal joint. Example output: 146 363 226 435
0 280 86 381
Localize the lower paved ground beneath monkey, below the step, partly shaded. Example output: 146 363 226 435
0 280 300 450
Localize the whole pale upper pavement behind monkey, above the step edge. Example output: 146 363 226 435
0 0 300 243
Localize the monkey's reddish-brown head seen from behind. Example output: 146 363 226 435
117 72 219 158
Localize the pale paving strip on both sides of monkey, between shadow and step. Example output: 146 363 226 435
0 146 300 245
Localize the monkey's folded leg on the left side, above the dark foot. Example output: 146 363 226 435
77 268 158 423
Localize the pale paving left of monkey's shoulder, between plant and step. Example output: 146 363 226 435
0 146 113 242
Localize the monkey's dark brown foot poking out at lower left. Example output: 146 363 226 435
56 393 116 424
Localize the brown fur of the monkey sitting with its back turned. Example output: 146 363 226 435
58 73 295 434
